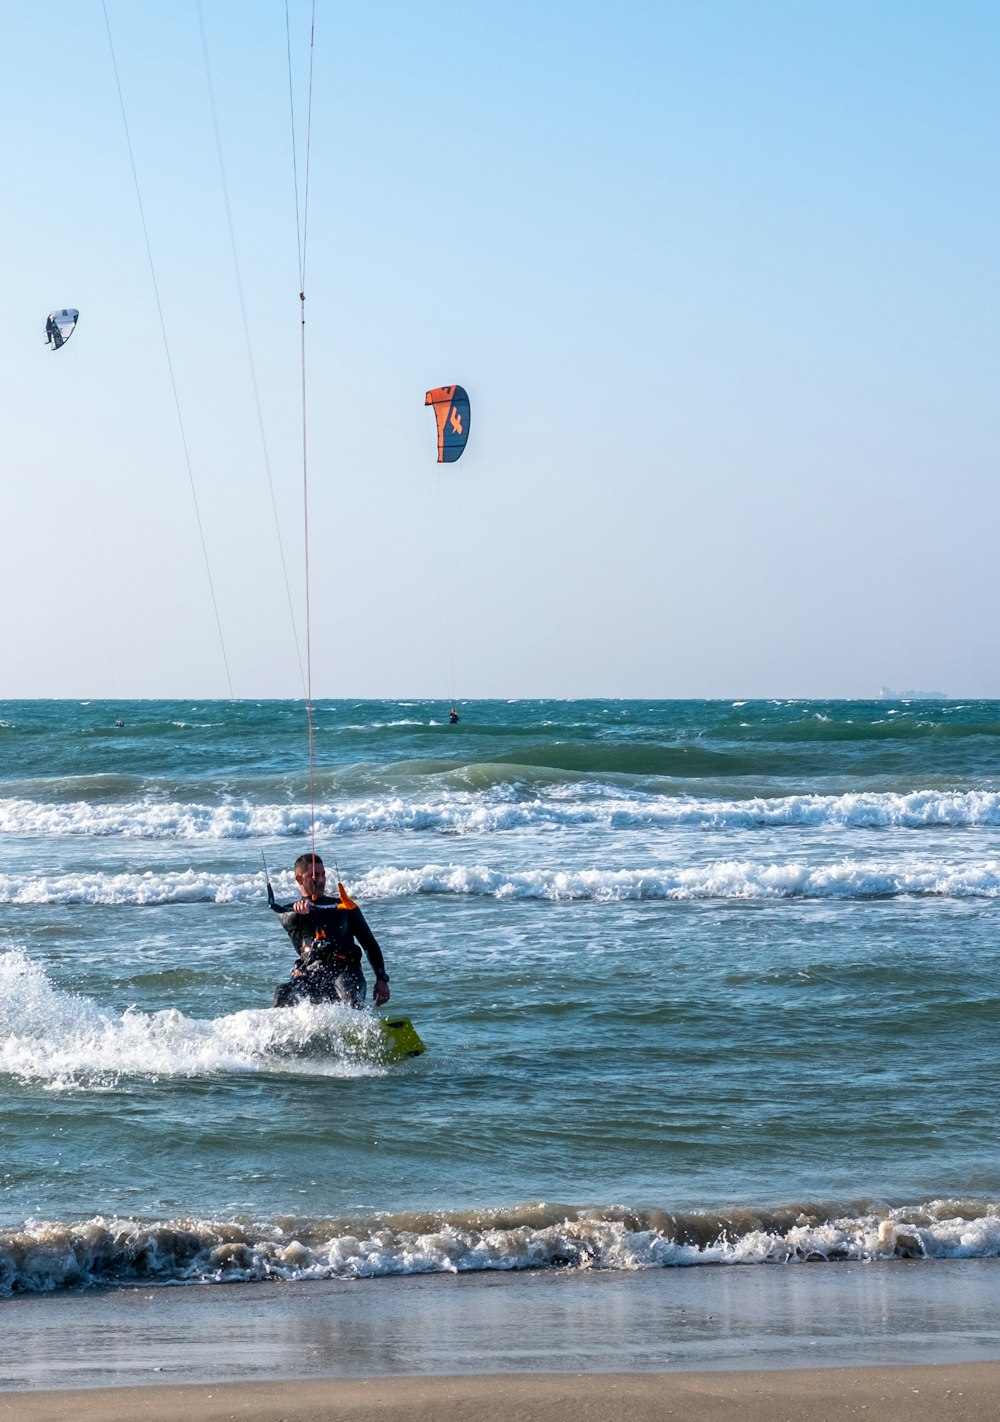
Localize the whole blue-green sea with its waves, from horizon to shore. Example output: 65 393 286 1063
0 700 1000 1307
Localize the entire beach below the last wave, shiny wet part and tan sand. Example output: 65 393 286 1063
0 1260 1000 1422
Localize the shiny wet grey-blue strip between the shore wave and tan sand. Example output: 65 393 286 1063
0 1258 1000 1393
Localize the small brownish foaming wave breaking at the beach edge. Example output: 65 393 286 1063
0 1200 1000 1297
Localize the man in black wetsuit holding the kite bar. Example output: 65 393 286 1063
267 855 390 1007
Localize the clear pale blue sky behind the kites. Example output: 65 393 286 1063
0 0 1000 701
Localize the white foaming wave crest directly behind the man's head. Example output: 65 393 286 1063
0 859 1000 907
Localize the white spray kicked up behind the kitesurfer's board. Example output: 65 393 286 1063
0 950 384 1089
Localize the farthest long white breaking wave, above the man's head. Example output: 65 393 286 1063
0 782 1000 840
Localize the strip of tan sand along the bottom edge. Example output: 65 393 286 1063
0 1362 1000 1422
